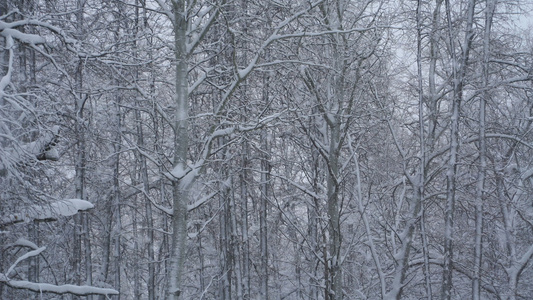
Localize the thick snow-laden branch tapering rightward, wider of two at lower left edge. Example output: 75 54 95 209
0 199 94 226
